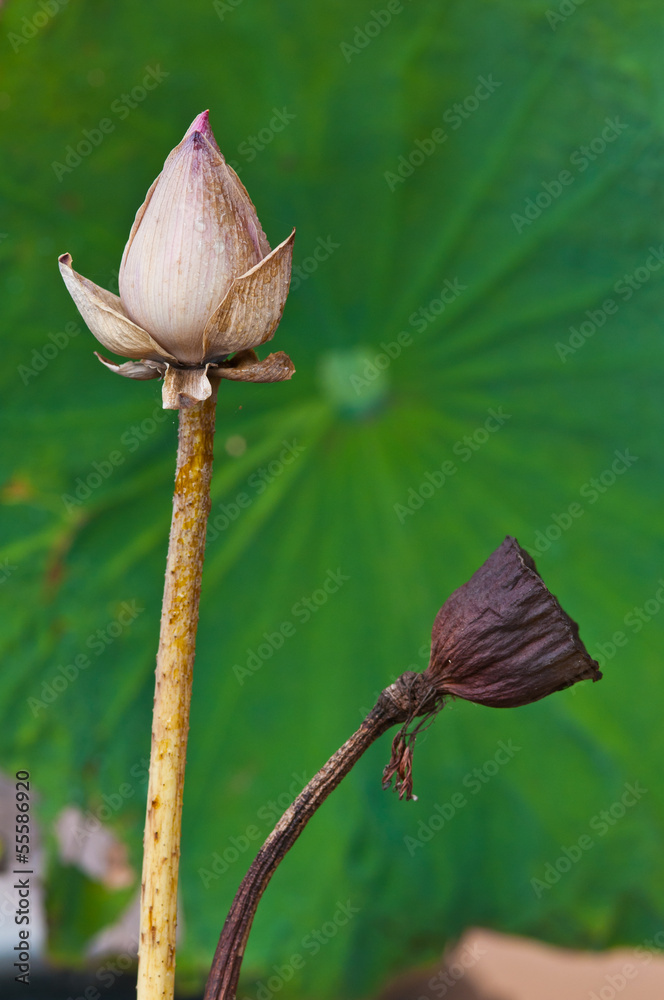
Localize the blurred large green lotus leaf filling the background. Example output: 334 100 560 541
0 0 664 998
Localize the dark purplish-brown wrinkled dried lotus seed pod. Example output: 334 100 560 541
424 536 602 707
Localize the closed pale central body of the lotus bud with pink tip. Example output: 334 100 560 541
120 122 270 364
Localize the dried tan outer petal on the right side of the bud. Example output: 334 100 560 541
203 230 295 360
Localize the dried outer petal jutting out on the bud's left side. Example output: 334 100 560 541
58 253 175 361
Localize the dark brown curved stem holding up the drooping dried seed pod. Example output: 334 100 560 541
204 685 406 1000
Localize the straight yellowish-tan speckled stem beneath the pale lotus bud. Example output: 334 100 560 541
137 390 218 1000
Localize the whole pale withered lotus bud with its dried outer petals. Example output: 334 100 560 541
59 111 295 409
